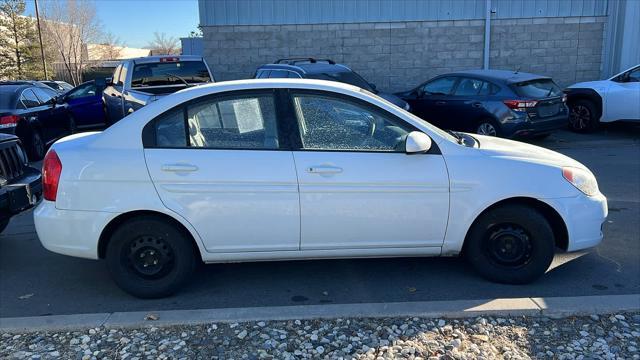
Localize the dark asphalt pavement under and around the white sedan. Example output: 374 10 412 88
0 126 640 317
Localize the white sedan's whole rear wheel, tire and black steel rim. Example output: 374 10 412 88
106 216 196 298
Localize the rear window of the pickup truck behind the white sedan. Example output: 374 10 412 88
131 61 211 88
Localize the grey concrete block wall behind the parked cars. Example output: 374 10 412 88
203 17 606 91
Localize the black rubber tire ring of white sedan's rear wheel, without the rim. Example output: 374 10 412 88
106 216 197 299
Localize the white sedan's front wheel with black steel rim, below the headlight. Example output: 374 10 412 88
464 205 555 284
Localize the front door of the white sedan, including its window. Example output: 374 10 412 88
290 90 449 250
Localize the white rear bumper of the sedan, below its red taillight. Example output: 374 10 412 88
33 200 118 259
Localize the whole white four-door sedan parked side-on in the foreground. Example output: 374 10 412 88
34 79 607 297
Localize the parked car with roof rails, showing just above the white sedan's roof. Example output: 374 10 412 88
253 58 409 110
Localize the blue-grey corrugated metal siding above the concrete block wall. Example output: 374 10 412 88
198 0 608 26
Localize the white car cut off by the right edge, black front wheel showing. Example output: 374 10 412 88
564 64 640 132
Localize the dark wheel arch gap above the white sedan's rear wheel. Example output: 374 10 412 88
98 210 203 261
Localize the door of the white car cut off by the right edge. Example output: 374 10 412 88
602 67 640 121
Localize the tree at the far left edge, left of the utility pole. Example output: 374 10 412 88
0 0 44 79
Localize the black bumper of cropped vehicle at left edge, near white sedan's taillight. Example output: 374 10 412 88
0 166 42 220
